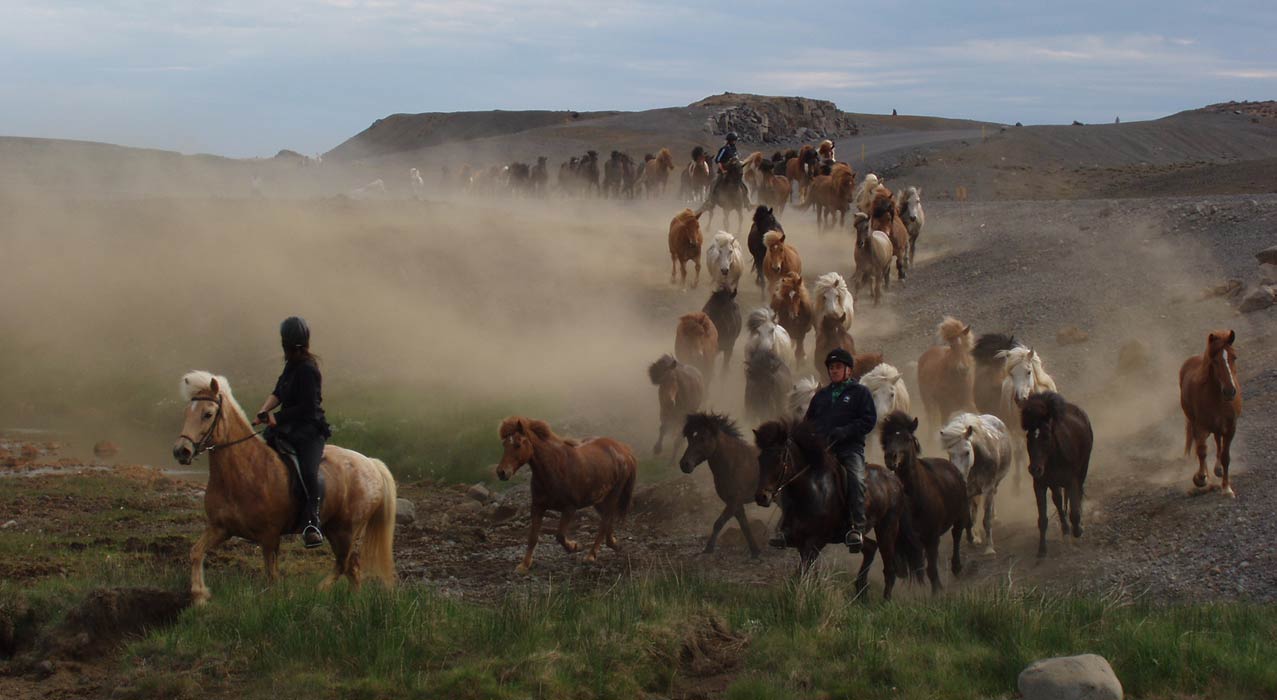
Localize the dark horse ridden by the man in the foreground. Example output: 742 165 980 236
753 420 918 599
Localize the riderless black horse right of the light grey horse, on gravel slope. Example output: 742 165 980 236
1020 391 1094 558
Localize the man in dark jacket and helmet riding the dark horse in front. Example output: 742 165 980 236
803 347 877 553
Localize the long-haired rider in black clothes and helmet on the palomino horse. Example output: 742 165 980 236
255 316 332 548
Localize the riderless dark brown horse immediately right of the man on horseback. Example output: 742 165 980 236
879 411 971 594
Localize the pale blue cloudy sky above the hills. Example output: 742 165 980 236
0 0 1277 157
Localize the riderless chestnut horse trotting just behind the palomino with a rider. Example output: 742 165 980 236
497 415 639 574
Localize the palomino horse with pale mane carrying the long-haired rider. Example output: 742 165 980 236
172 372 396 605
